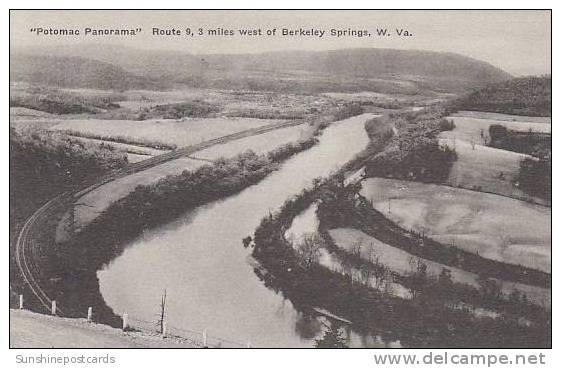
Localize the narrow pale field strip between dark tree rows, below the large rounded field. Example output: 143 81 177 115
329 228 551 306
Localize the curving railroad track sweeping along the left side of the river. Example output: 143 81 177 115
15 120 305 316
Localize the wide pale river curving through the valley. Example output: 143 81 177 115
98 114 394 347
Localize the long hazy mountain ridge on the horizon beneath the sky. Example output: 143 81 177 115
10 45 511 93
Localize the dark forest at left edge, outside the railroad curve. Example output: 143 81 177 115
10 128 127 304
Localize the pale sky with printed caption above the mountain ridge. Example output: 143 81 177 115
10 10 551 76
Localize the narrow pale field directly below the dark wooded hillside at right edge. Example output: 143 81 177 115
440 115 551 145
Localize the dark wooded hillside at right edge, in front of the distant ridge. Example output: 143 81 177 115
456 75 551 116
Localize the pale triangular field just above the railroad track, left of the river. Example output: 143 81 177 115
51 118 280 147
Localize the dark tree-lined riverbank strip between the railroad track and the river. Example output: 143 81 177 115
38 110 364 326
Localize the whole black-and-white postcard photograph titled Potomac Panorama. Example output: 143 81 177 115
4 4 553 354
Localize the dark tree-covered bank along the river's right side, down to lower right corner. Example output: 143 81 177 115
253 178 550 347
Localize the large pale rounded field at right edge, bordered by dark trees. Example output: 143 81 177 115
362 178 551 273
